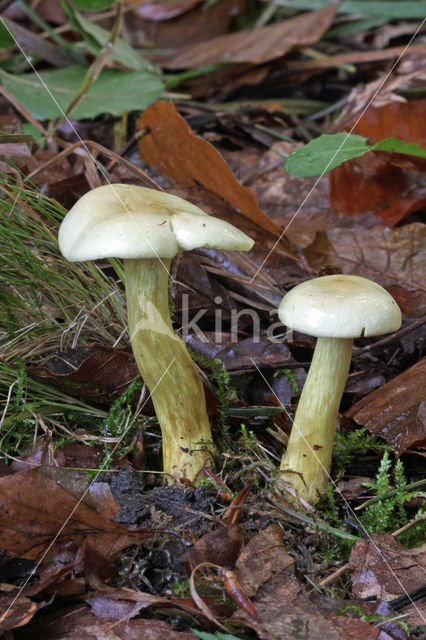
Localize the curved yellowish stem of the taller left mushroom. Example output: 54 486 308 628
124 258 212 482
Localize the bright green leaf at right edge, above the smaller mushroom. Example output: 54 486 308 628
284 131 426 178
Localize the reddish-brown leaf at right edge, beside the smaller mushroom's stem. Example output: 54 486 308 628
344 357 426 453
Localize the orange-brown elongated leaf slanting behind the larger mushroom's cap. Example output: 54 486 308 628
138 101 298 246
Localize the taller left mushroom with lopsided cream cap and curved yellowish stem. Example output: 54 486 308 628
59 184 253 482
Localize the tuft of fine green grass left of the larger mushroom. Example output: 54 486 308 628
0 173 126 363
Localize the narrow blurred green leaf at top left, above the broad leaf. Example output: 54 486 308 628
65 5 158 73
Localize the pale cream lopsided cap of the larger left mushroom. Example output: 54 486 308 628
58 184 254 262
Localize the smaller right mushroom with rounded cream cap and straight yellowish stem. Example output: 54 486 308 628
278 275 401 504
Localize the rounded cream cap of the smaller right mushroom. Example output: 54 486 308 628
278 275 402 338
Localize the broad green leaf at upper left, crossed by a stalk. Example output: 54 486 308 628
0 65 164 120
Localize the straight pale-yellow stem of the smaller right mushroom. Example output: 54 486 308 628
278 338 353 504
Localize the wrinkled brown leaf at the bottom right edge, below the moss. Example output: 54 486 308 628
349 533 426 600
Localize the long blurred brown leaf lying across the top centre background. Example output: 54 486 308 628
164 4 338 69
